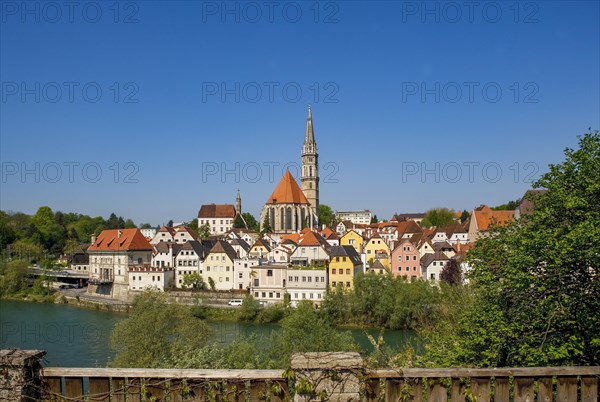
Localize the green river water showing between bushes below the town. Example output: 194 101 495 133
0 300 414 367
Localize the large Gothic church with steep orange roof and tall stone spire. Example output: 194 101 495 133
260 105 319 234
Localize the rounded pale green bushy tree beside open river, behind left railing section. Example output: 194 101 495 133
110 290 209 368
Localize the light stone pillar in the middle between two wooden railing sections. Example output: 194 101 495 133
290 352 365 402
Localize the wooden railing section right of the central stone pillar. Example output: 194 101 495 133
367 367 600 402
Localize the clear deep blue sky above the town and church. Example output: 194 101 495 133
0 0 600 225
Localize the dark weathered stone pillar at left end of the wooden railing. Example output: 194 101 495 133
0 349 46 401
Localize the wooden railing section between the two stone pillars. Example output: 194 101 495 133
41 367 289 402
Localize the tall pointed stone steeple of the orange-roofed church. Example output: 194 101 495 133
302 105 319 221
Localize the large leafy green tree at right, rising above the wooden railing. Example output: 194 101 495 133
429 131 600 367
